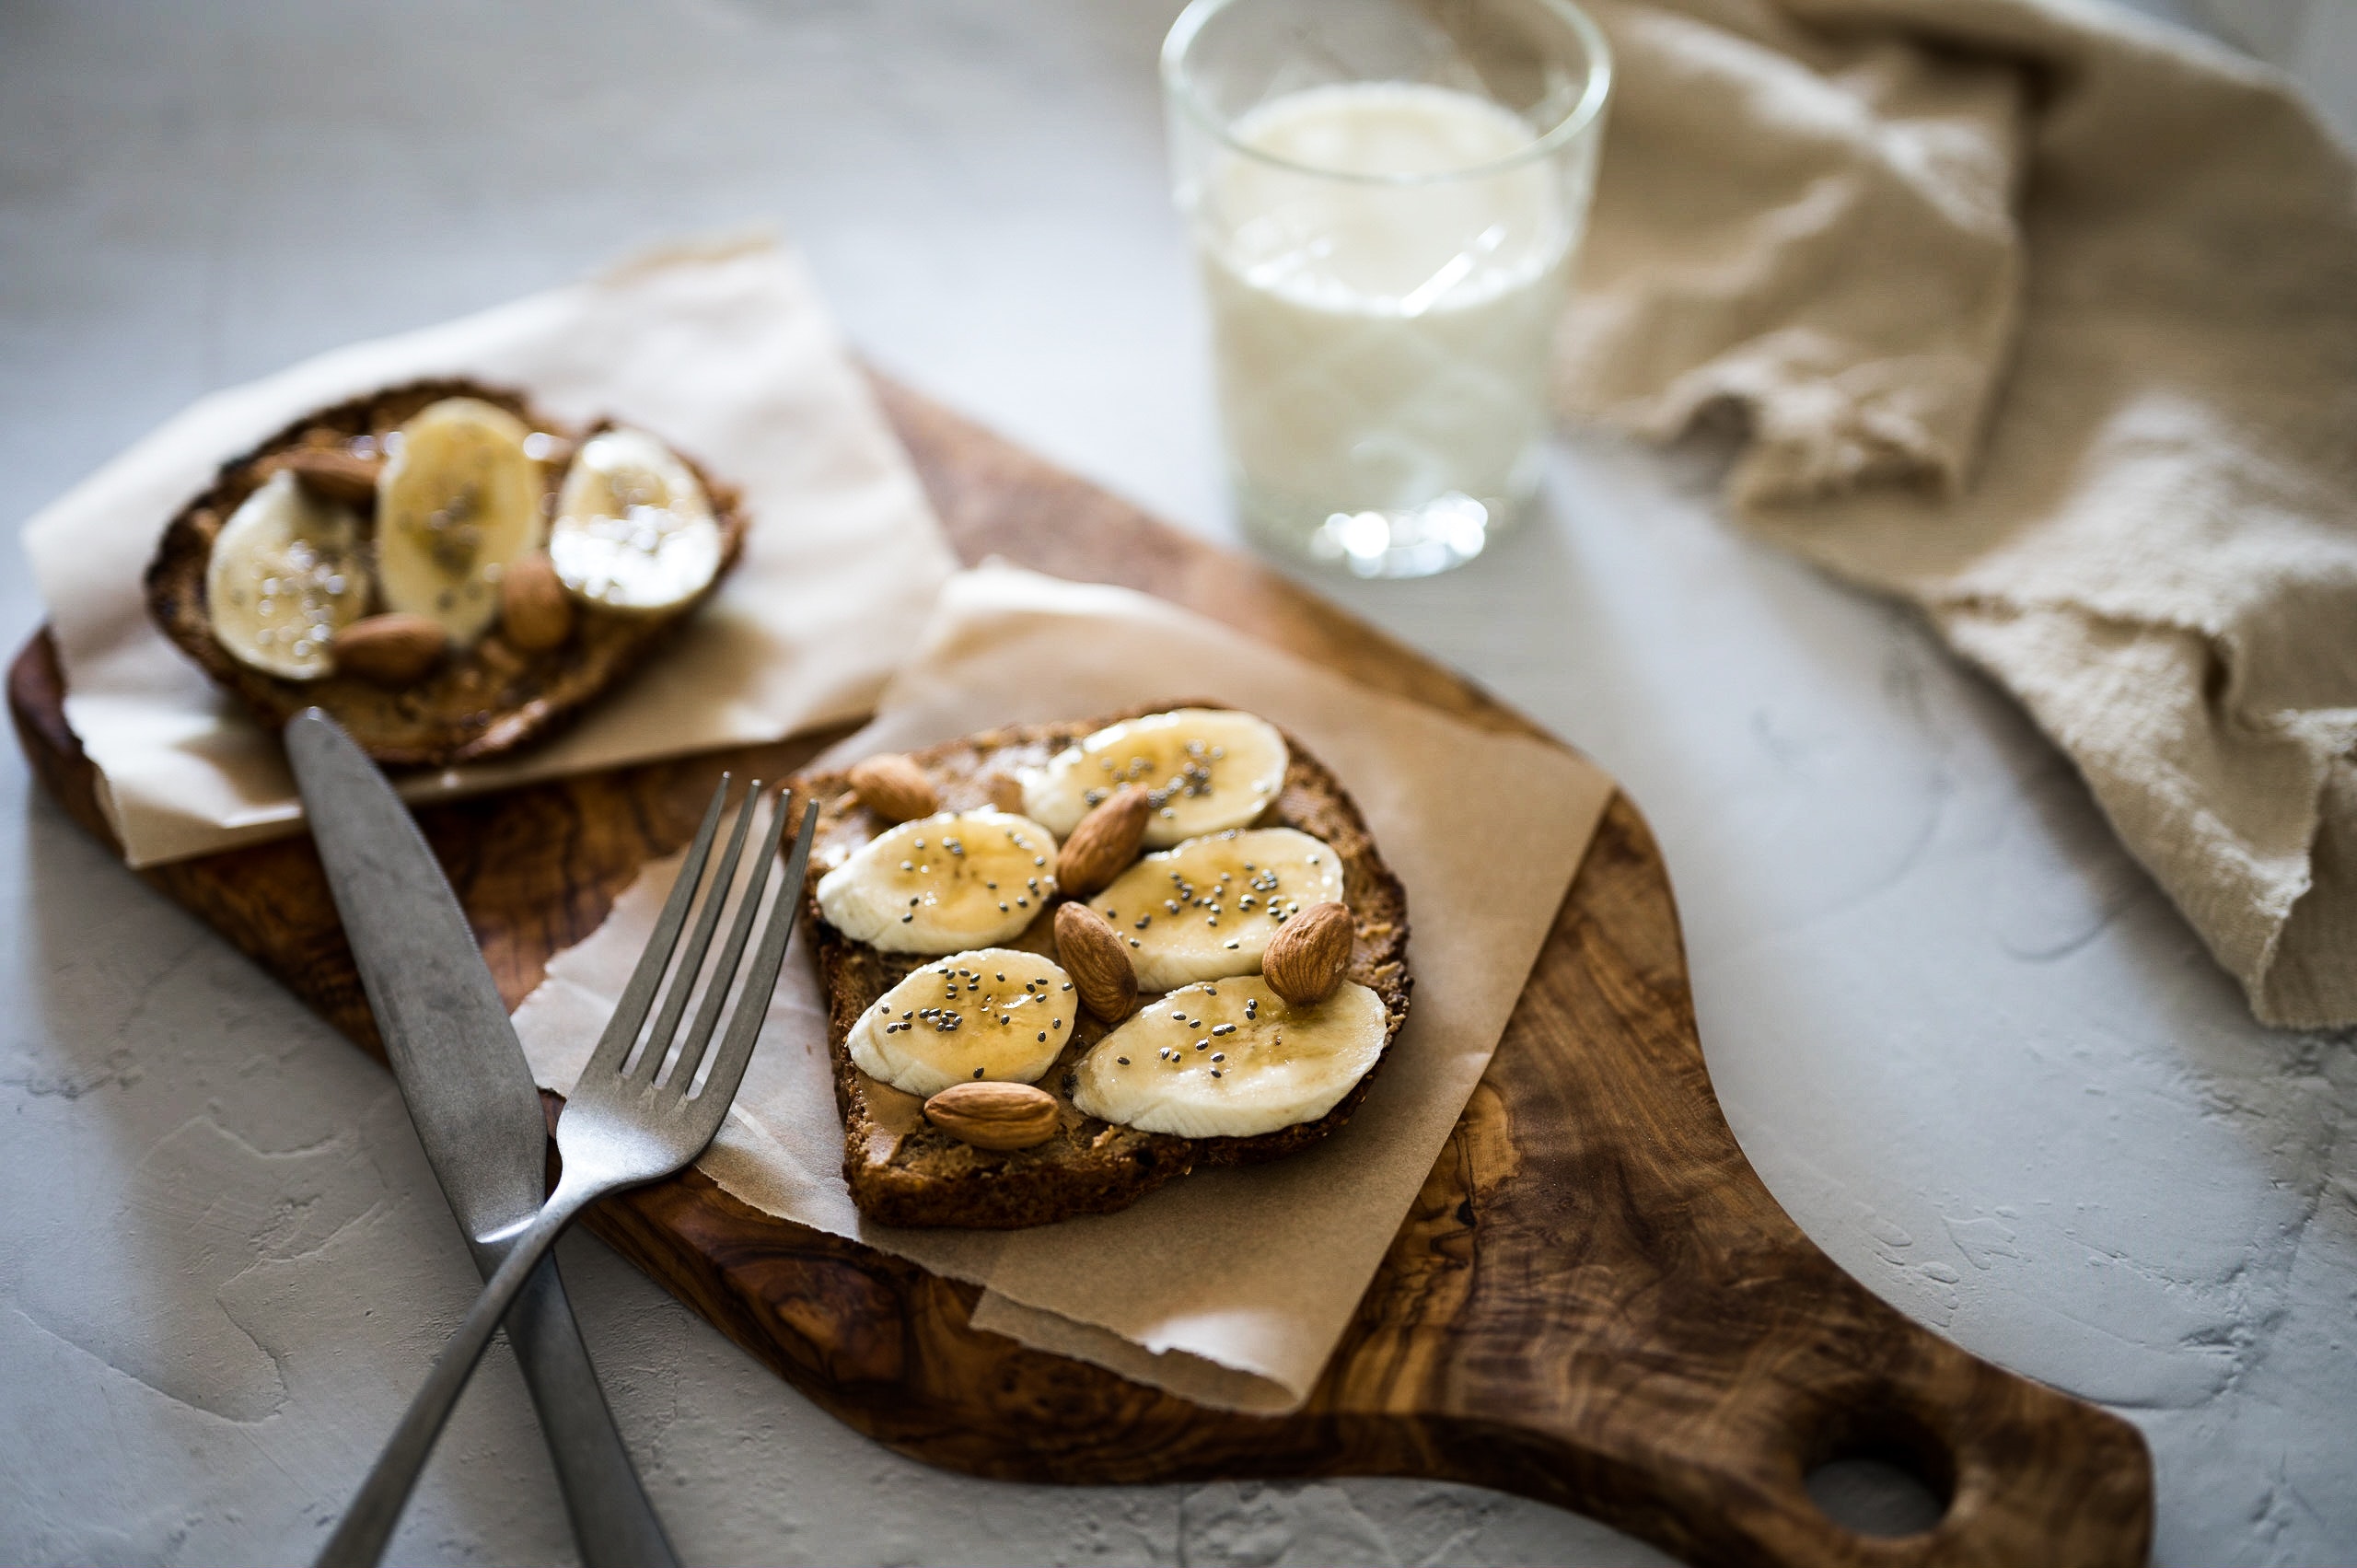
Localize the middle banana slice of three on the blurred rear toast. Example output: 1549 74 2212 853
377 399 540 648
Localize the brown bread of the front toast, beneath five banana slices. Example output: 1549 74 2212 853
795 703 1411 1231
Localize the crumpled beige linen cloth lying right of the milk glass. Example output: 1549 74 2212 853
1558 0 2357 1028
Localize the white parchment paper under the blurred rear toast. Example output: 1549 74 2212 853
24 240 957 865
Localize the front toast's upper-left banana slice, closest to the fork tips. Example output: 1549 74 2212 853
818 811 1056 953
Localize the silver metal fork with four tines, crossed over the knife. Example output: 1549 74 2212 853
319 776 818 1568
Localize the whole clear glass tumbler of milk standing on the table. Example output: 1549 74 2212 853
1162 0 1612 577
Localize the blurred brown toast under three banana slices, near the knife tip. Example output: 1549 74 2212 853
146 379 748 766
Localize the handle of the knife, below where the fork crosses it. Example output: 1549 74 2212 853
494 1248 679 1568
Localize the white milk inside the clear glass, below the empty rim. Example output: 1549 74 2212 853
1195 83 1586 573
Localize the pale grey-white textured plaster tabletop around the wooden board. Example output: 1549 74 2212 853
0 0 2357 1563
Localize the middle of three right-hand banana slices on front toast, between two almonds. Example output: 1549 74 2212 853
1089 828 1341 991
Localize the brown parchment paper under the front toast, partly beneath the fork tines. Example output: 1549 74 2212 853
517 563 1612 1410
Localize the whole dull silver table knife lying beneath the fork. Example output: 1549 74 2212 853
285 707 679 1568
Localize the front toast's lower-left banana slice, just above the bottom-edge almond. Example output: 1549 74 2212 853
849 947 1073 1094
